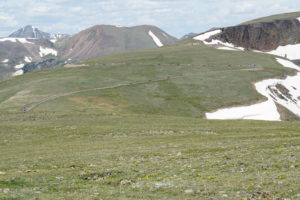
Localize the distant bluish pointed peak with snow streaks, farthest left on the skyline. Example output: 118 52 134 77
8 25 51 40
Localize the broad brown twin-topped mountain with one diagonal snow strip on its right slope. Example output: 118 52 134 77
62 25 177 61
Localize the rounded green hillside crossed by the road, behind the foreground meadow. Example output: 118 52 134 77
0 43 293 117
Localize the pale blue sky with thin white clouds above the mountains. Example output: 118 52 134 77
0 0 300 37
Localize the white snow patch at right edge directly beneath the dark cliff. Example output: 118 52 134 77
266 44 300 60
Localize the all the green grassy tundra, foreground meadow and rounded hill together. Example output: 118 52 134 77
0 40 300 200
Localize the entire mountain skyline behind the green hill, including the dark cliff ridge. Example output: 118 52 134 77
0 13 300 79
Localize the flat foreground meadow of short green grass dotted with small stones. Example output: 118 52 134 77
0 111 300 199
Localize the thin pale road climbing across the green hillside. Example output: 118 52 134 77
21 69 252 112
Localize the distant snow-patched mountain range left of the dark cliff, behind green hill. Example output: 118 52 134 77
0 25 177 79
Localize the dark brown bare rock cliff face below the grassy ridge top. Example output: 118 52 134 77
211 19 300 51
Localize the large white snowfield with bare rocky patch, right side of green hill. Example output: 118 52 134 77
206 58 300 121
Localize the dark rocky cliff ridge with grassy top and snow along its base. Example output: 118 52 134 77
192 12 300 60
